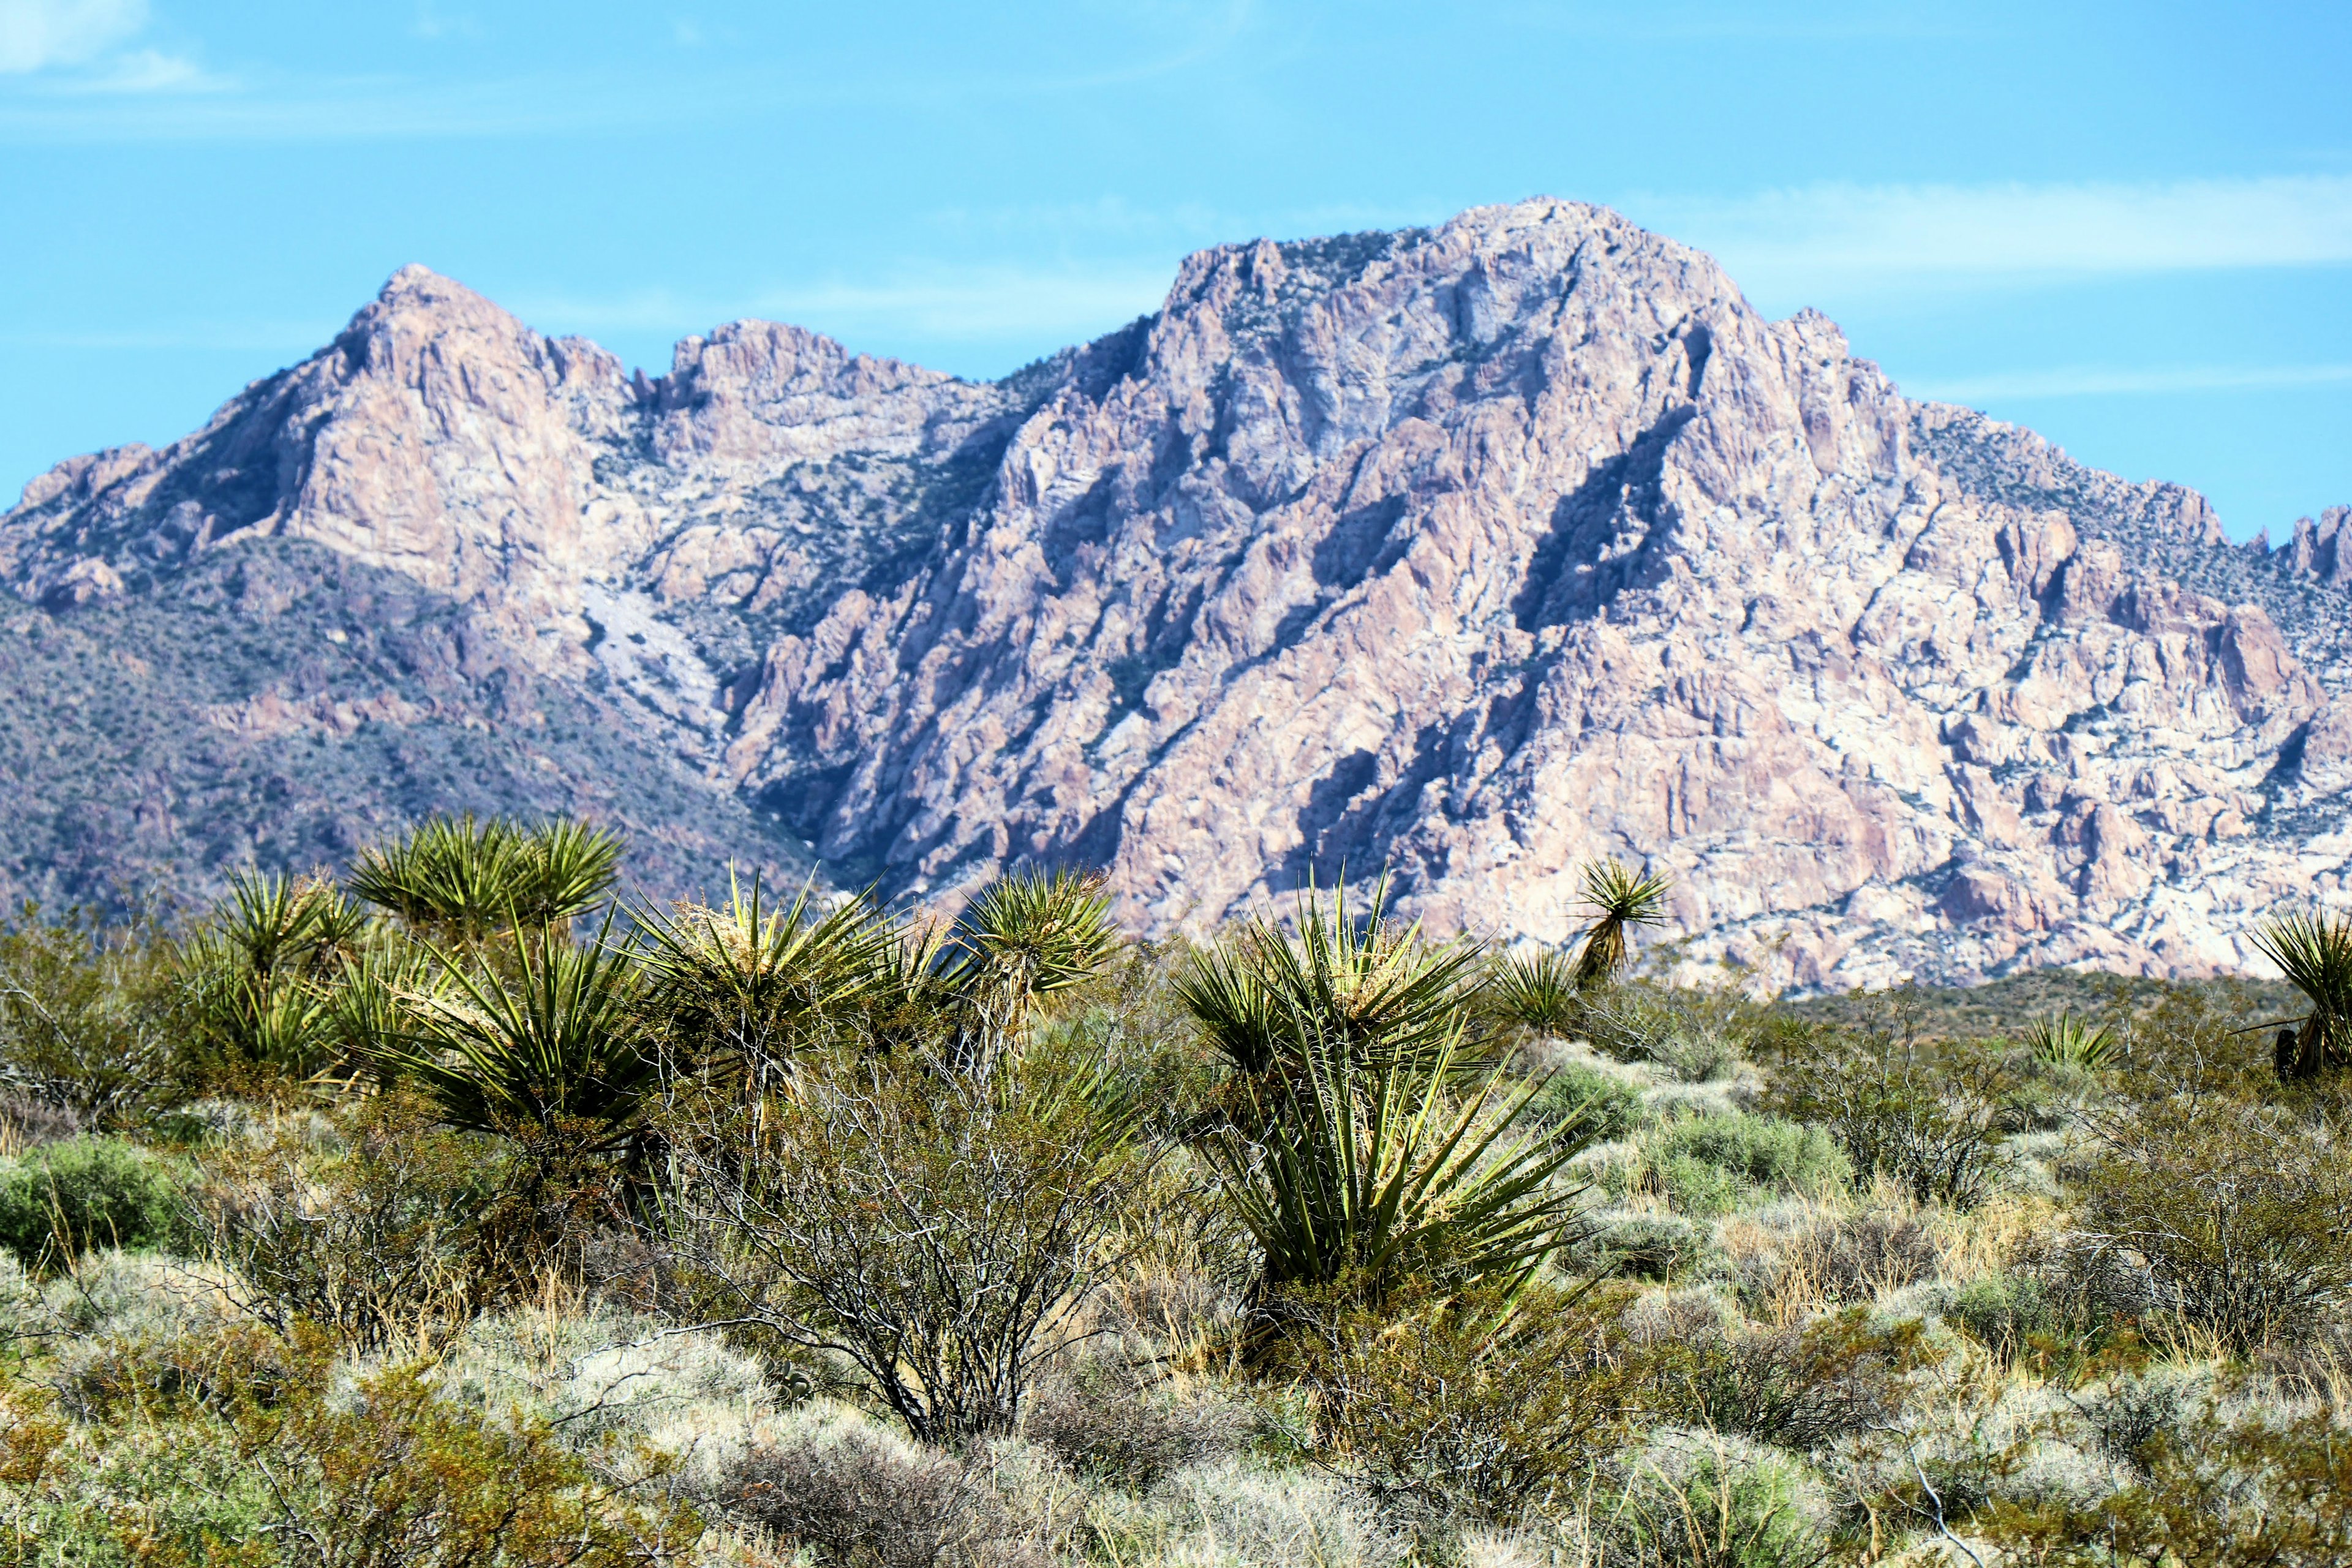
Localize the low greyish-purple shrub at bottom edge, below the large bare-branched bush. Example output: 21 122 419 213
715 1425 1016 1568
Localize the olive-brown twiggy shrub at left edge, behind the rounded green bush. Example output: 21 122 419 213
0 905 188 1128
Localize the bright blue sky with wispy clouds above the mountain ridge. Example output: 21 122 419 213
0 0 2352 538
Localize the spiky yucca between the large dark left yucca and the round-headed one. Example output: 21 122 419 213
638 872 899 1077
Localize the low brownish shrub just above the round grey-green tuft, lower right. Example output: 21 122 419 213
1649 1310 1933 1450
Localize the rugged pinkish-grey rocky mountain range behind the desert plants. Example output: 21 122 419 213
0 200 2352 987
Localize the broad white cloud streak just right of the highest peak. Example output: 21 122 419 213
1627 174 2352 289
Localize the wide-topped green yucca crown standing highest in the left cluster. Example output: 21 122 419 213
350 811 621 943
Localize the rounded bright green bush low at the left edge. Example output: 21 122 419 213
0 1138 184 1267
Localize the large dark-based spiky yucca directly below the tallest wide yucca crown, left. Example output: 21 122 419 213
367 917 654 1140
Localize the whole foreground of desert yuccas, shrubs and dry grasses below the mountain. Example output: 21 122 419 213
0 818 2352 1568
